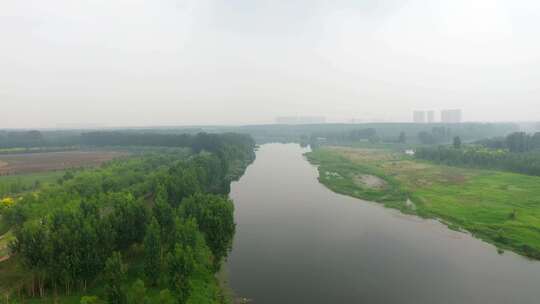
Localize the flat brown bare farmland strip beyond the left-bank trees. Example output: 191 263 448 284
0 151 127 175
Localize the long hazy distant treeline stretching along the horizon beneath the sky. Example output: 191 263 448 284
0 123 519 148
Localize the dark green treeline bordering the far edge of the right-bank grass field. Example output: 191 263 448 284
415 146 540 175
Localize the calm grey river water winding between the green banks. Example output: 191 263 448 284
227 144 540 304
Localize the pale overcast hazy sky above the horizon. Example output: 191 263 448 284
0 0 540 128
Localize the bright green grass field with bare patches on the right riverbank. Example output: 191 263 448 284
307 147 540 259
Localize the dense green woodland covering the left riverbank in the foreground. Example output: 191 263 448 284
3 134 254 303
